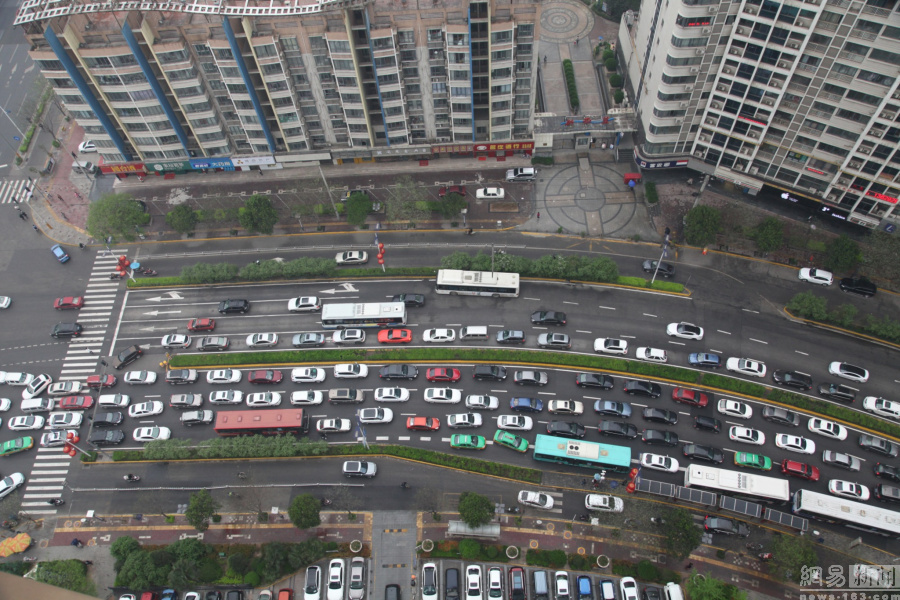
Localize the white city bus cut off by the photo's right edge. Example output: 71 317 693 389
791 490 900 538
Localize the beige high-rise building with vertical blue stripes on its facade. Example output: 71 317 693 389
15 0 539 172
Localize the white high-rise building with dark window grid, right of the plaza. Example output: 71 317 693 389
618 0 900 227
